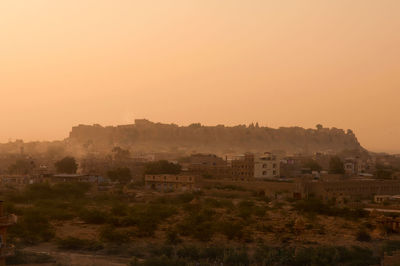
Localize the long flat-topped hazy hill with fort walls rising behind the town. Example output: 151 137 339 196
66 119 363 153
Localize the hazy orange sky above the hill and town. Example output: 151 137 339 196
0 0 400 152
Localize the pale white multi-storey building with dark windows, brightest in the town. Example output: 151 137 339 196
254 152 280 178
